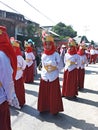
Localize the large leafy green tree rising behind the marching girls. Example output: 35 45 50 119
52 22 77 38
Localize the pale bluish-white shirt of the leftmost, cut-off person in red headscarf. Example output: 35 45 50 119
0 51 15 104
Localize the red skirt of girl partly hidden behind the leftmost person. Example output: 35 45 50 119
14 77 25 107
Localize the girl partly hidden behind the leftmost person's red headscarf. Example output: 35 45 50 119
12 40 26 107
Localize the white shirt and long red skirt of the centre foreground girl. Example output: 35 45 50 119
37 35 63 114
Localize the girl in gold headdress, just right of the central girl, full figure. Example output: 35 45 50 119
62 38 79 99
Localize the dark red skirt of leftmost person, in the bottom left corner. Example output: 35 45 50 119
0 101 11 130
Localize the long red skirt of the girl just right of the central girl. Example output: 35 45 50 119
62 69 78 98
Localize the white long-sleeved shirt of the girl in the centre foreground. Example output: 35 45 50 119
41 52 60 82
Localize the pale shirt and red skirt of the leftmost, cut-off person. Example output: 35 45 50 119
0 51 13 130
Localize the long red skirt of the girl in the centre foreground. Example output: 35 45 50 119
38 78 63 114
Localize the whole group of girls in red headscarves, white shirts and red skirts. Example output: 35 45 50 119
0 26 98 130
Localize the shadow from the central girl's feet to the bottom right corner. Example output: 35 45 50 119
40 113 98 130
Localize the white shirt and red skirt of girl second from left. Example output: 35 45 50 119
14 55 26 107
